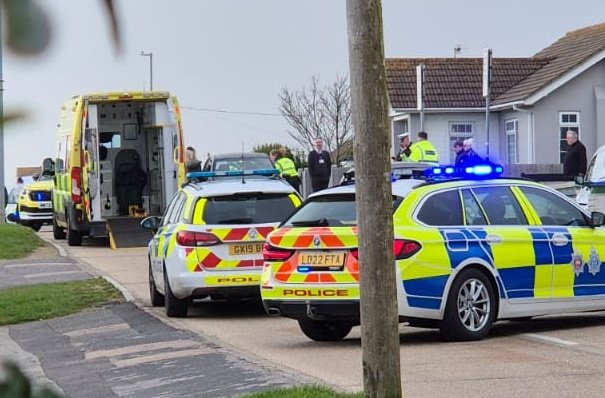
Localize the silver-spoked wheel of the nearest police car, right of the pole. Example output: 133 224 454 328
441 269 496 341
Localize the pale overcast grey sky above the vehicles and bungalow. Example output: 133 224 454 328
2 0 605 188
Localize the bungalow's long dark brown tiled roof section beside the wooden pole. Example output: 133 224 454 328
386 58 550 109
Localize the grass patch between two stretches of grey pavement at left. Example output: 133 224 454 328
0 278 123 326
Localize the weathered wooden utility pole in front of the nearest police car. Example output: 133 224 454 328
347 0 401 398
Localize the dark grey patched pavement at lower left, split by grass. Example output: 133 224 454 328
0 232 302 397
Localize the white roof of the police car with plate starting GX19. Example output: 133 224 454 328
183 177 296 197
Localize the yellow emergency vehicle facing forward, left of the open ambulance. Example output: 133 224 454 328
17 175 54 231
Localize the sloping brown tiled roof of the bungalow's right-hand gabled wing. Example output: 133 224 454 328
493 23 605 105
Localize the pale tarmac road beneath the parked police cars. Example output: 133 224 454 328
42 233 605 397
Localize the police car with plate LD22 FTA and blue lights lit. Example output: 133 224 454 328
261 165 605 341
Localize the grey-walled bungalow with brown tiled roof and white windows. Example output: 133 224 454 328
386 23 605 168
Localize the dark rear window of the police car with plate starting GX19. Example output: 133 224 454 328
203 193 295 224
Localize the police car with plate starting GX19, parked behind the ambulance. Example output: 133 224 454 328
141 169 301 317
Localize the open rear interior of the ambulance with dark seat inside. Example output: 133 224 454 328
84 101 178 220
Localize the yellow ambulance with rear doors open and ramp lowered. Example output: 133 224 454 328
52 91 185 248
